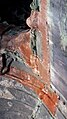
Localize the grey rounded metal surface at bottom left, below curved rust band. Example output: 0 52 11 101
0 78 52 119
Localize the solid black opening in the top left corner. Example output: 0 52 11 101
0 0 32 29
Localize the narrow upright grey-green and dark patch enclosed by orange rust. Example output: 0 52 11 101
30 29 43 60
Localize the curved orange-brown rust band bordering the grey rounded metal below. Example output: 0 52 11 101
0 68 58 114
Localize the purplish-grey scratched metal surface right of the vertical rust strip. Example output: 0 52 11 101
47 0 67 119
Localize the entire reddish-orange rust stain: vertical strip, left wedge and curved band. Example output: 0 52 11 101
2 0 58 114
